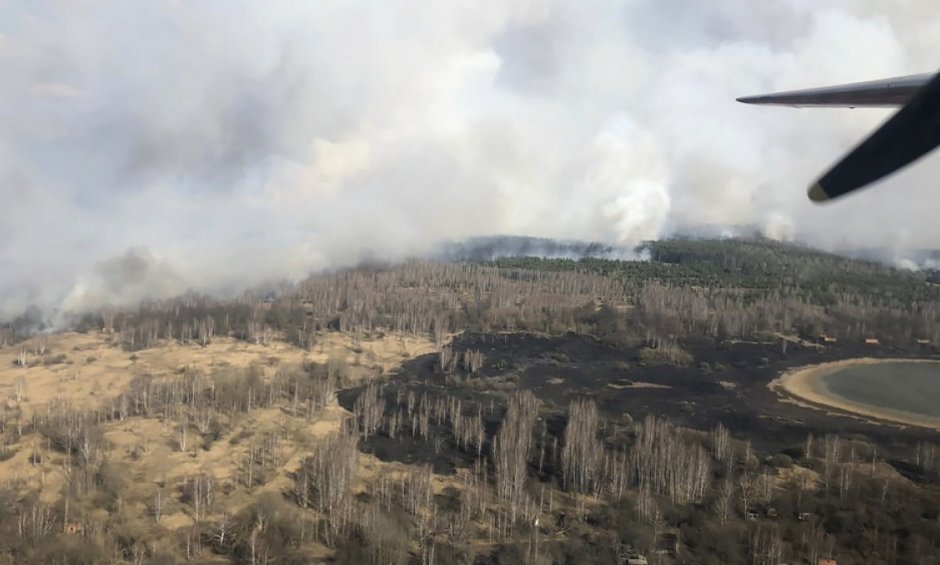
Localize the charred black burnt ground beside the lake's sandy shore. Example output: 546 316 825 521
339 333 935 473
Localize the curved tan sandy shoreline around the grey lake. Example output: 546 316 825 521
767 357 940 431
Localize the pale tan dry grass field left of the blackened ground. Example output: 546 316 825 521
0 332 434 555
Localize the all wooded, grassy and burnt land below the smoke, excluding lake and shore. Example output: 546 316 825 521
0 239 940 564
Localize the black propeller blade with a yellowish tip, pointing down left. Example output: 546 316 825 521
809 69 940 202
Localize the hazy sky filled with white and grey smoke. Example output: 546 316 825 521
0 0 940 317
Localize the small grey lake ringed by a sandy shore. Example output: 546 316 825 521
818 361 940 422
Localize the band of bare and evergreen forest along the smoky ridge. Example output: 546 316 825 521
0 235 940 350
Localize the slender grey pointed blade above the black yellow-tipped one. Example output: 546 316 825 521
738 73 934 108
